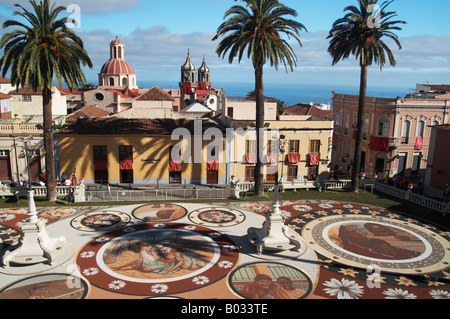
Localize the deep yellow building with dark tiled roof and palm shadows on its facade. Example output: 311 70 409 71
57 118 227 185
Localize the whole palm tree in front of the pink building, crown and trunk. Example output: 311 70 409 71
328 0 406 192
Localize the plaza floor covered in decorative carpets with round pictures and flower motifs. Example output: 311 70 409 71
0 200 450 300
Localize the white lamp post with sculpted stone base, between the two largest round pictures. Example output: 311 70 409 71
247 131 307 254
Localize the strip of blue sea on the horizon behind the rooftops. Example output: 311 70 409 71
139 81 412 106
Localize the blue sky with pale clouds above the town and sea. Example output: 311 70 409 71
0 0 450 97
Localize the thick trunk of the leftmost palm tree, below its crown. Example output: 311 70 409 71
43 87 56 201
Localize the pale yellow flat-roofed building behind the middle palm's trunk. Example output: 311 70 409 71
227 116 333 183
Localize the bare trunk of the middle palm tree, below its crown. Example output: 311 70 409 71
255 63 264 196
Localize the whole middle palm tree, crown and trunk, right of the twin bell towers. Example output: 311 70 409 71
213 0 306 195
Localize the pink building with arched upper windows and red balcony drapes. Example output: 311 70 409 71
332 92 450 179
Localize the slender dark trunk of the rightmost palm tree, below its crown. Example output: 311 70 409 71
351 65 367 192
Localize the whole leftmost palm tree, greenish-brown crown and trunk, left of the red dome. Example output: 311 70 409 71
0 0 92 201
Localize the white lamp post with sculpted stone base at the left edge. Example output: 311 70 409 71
2 136 66 266
